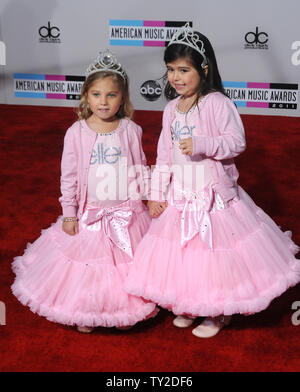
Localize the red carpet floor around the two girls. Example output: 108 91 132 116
0 105 300 372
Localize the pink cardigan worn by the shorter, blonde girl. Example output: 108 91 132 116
59 118 150 219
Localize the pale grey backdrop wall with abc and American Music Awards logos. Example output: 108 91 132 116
0 0 300 116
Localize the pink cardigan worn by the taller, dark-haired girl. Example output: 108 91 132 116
151 92 246 201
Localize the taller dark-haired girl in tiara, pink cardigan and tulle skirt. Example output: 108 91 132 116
126 25 300 338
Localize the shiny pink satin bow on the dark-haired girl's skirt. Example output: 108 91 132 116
175 188 213 249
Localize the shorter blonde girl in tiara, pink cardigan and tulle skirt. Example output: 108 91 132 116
12 51 156 333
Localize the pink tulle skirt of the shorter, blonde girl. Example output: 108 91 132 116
12 202 157 327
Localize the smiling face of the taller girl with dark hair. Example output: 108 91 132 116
167 58 200 98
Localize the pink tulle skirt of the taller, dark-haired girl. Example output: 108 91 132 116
125 187 300 316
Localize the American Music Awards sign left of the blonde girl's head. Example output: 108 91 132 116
14 73 85 100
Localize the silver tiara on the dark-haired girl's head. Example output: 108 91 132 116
168 23 207 68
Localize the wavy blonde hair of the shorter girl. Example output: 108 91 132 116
77 71 134 120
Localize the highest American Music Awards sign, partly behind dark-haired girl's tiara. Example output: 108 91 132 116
109 19 193 46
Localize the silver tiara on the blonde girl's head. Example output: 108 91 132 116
85 49 126 81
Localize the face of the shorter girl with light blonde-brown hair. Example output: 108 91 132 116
87 76 123 122
